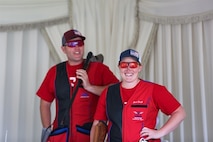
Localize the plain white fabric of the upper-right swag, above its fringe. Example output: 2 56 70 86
140 0 213 16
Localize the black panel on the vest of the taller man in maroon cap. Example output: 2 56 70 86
55 62 70 127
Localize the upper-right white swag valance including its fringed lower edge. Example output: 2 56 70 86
139 0 213 24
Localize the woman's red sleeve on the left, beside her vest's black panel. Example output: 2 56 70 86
94 88 108 120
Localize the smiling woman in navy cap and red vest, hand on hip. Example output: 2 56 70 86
91 49 186 142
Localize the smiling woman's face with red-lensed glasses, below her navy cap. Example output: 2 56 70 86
118 57 142 83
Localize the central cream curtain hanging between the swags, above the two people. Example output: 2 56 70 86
72 0 140 75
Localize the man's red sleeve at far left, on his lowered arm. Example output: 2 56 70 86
36 66 56 102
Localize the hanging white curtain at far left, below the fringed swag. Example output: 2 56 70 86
0 30 51 142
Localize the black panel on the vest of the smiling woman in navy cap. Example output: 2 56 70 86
106 83 123 142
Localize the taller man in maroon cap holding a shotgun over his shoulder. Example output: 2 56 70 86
37 29 118 142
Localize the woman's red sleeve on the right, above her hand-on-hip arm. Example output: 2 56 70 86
153 85 180 115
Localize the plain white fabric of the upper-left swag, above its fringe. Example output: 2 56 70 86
0 0 68 25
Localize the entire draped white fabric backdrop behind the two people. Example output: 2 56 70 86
0 0 213 142
